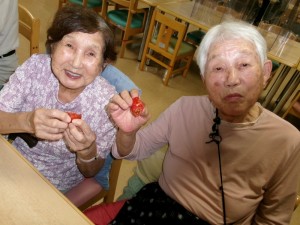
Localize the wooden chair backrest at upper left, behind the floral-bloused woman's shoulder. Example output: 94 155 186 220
19 4 40 55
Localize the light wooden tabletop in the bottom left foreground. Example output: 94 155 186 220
0 135 93 225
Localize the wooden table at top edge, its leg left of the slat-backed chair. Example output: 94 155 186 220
138 0 192 61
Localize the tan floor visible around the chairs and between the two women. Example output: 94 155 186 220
17 0 300 225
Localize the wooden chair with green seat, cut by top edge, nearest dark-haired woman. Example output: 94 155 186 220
102 0 148 58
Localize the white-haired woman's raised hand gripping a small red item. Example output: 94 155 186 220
107 90 150 133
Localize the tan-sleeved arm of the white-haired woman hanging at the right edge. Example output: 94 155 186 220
253 145 300 225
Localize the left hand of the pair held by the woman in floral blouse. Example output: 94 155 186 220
27 108 71 141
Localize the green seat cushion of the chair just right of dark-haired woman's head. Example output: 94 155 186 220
107 9 144 28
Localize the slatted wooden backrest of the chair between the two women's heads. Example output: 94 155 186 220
148 10 187 58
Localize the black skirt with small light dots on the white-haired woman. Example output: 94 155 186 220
110 182 209 225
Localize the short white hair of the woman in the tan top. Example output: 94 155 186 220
196 21 267 78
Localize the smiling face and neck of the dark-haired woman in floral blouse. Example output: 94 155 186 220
51 32 104 102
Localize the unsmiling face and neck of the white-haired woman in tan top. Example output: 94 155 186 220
204 39 272 122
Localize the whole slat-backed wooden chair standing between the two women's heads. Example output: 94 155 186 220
139 10 196 85
